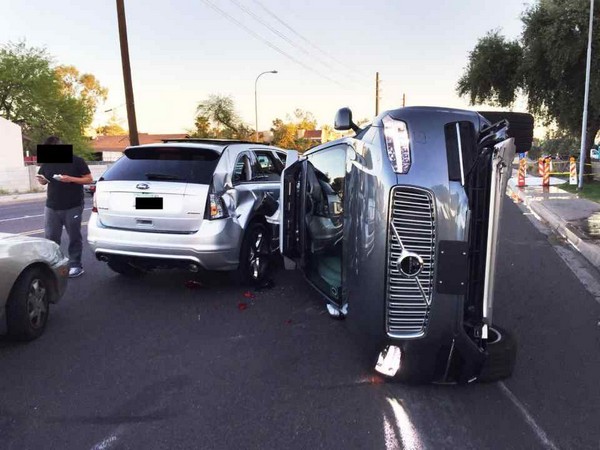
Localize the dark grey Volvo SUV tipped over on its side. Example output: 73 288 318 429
280 107 531 382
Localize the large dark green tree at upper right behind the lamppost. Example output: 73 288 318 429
457 0 600 177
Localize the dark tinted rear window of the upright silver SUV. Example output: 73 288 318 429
102 147 220 184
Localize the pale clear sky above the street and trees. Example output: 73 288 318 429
0 0 526 133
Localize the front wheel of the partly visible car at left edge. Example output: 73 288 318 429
6 267 53 341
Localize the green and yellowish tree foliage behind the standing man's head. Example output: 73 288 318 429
0 42 106 157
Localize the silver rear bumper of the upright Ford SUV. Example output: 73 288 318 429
88 213 243 270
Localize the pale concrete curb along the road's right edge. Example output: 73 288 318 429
508 184 600 270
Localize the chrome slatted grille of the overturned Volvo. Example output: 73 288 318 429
386 186 435 338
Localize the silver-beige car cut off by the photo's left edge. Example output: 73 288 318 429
0 233 69 341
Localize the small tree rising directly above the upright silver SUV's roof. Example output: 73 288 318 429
192 95 254 140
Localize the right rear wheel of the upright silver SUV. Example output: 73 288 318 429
239 222 270 284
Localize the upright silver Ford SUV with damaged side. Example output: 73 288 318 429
88 139 297 282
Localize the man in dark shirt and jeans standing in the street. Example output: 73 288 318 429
37 136 93 278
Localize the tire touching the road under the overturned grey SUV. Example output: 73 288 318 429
478 326 517 383
